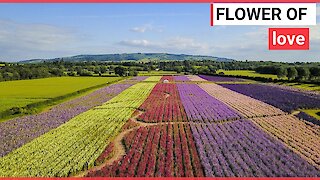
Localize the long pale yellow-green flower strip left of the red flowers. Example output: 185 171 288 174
0 83 155 177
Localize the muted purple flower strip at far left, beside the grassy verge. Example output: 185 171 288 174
0 84 131 157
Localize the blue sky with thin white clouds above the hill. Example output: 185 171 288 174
0 3 320 62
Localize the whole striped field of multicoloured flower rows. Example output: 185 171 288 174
0 75 320 177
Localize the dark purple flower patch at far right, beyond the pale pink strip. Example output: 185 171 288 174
221 84 320 112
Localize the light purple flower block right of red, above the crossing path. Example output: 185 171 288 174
177 84 241 122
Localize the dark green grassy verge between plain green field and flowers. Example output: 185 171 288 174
0 78 125 122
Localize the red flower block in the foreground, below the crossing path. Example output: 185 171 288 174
88 124 204 177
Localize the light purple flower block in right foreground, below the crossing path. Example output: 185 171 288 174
191 120 320 177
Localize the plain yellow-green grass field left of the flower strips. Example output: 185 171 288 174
0 77 121 112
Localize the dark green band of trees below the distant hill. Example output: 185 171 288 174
0 60 320 82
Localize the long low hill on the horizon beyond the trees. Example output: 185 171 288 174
20 53 234 63
